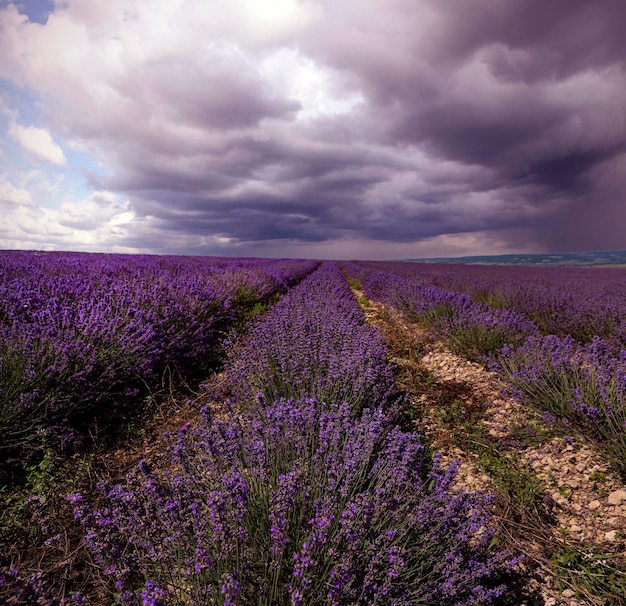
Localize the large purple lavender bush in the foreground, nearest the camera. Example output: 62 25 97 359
70 399 515 606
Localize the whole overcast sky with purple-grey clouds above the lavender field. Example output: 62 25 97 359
0 0 626 259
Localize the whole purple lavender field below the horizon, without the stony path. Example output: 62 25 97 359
0 252 626 605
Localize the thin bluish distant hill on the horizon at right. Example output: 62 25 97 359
402 250 626 267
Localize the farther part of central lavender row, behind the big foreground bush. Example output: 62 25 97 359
225 263 397 408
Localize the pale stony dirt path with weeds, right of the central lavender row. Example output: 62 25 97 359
354 290 626 606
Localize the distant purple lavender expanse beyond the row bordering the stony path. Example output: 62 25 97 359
358 262 626 347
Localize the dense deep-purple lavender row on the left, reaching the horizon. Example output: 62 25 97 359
0 251 315 451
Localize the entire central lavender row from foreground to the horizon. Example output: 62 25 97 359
59 263 517 606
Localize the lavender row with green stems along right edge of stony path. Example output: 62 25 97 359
346 263 626 477
